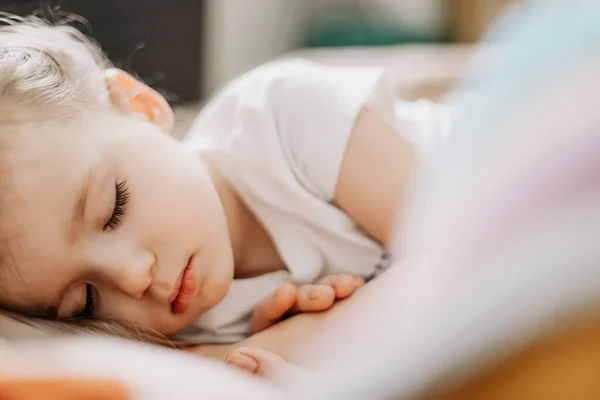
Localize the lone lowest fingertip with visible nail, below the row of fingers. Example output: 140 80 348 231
225 347 307 381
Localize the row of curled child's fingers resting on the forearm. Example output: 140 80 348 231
250 274 365 334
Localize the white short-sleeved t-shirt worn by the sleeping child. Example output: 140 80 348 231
180 60 449 343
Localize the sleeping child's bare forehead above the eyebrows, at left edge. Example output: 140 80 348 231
0 117 101 309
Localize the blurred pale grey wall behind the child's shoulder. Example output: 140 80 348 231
202 0 445 95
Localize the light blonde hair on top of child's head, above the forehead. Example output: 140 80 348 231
0 17 110 126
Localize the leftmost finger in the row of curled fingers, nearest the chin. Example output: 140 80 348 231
250 283 297 334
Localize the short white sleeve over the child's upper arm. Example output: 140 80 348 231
269 60 395 202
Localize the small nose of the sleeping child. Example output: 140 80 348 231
94 250 156 299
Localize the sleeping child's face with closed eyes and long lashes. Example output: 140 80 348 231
0 113 233 335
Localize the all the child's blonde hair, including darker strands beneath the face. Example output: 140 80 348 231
0 15 184 347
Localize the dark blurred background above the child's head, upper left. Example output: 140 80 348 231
0 0 203 103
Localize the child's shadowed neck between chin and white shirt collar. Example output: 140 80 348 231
207 161 285 279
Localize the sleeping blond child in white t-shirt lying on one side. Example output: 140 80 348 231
0 18 451 360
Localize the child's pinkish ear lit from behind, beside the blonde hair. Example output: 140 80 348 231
105 68 175 133
